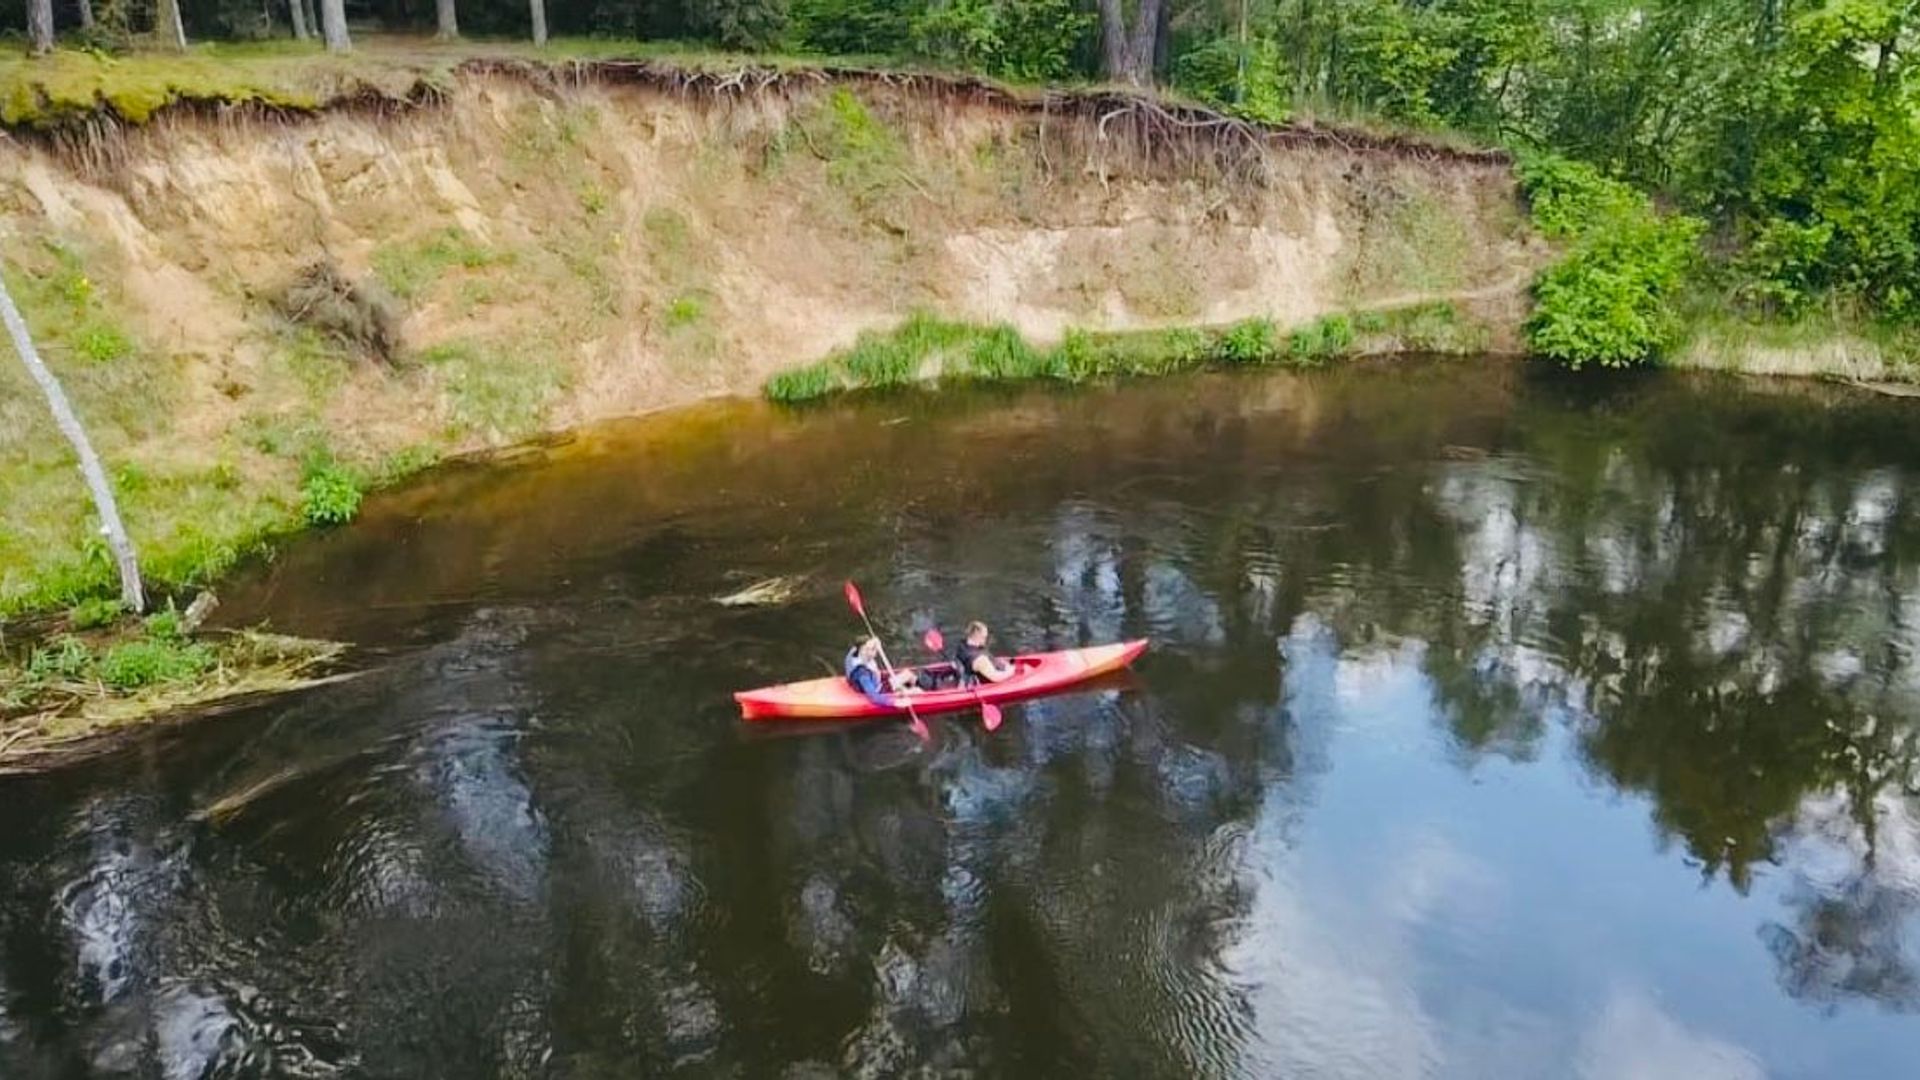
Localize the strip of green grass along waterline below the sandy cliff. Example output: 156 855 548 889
764 302 1488 404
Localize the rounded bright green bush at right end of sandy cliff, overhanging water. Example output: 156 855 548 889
1521 158 1705 369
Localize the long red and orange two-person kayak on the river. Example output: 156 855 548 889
733 640 1146 721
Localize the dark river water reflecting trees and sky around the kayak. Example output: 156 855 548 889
0 365 1920 1078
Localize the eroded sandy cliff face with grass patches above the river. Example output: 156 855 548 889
0 69 1544 599
